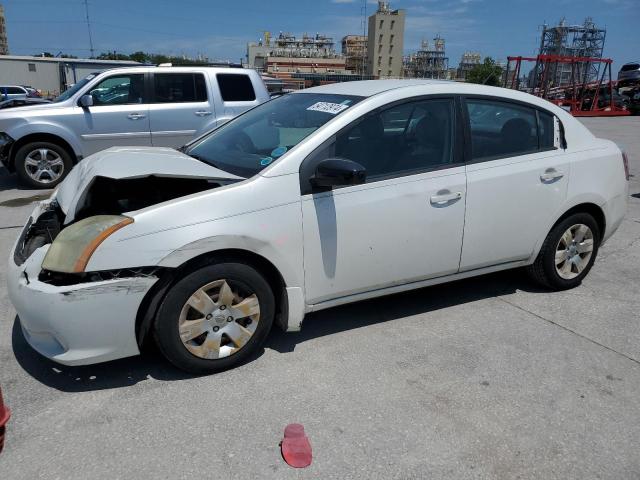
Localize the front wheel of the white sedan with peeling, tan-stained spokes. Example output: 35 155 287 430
154 262 275 374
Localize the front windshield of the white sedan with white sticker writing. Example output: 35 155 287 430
185 93 363 178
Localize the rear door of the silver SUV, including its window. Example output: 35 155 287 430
149 72 215 148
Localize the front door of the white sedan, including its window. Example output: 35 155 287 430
301 98 466 304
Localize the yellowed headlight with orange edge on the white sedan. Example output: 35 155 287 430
42 215 133 273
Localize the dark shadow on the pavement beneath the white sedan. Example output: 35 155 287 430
12 271 545 392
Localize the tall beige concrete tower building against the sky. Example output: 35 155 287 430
367 2 405 78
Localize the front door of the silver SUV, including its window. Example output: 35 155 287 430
67 73 151 156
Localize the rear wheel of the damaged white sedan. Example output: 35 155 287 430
527 213 601 290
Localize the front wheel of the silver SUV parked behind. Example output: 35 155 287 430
15 142 73 188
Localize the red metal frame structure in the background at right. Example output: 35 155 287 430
504 55 631 117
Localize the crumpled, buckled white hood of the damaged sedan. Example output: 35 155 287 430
56 147 244 223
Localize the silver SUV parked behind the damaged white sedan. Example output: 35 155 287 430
0 67 269 188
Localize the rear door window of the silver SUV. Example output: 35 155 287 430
153 73 207 103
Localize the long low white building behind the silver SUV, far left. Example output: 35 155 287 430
0 55 139 97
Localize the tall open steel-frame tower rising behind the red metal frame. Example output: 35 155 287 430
529 17 607 88
